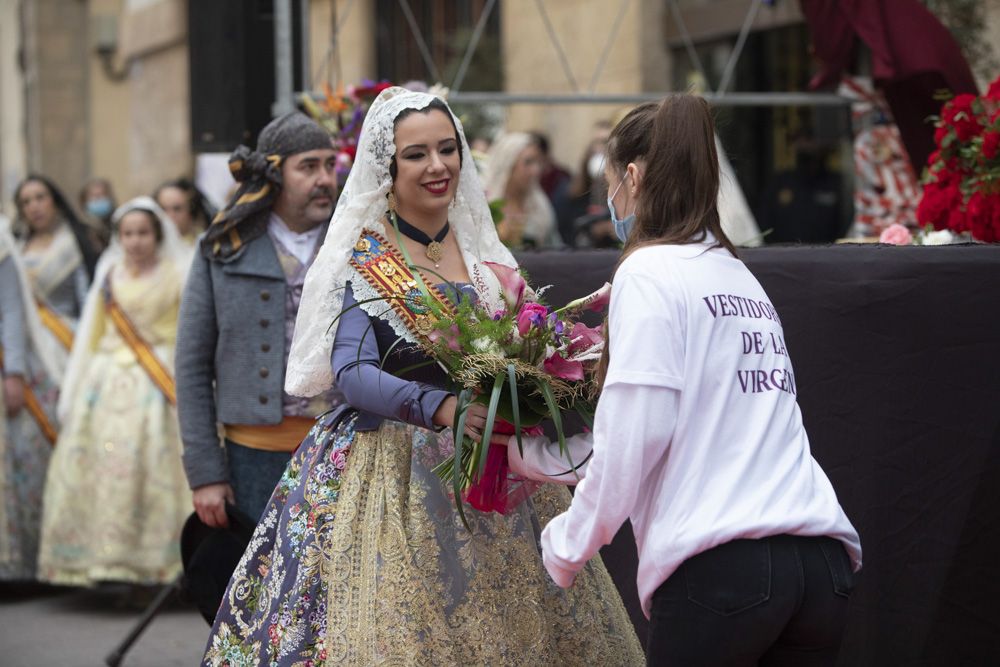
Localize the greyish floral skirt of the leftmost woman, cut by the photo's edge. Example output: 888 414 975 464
0 356 59 581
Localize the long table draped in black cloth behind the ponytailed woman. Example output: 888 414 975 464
518 245 1000 667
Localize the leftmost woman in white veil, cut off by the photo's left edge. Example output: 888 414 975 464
0 216 61 581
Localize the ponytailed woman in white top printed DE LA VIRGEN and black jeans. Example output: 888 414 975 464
508 95 861 666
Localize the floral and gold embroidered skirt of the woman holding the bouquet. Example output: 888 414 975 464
204 412 644 667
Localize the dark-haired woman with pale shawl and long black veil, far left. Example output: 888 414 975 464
14 175 97 366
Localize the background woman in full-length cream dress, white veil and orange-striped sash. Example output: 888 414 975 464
38 197 191 585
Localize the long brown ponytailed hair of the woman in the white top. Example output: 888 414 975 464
597 94 737 386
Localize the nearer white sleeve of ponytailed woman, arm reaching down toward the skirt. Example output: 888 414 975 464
541 273 684 586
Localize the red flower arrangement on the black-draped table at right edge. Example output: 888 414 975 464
917 77 1000 243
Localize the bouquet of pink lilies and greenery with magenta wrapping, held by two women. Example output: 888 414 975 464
414 262 611 521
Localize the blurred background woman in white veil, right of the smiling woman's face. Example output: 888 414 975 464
483 132 562 249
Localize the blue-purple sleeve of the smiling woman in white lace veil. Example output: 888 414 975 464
331 284 449 428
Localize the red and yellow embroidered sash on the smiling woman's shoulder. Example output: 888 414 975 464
351 229 455 338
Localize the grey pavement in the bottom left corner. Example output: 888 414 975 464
0 584 209 667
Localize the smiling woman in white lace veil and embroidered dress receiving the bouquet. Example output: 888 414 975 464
205 88 643 665
